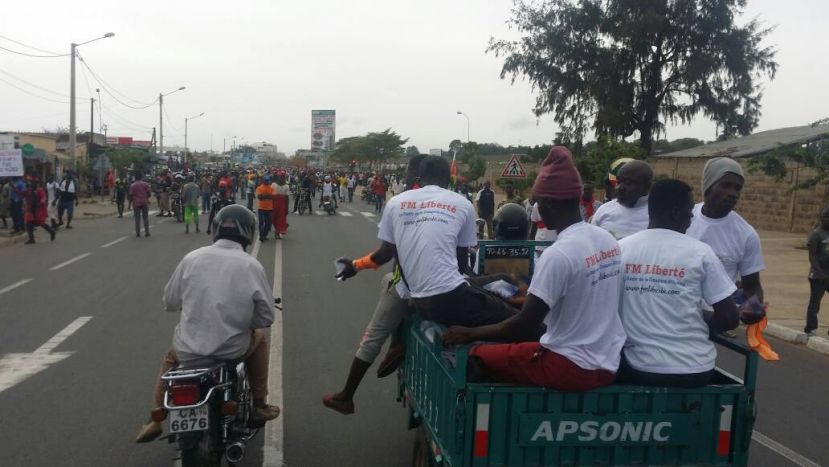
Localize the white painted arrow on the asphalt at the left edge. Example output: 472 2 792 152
0 316 92 392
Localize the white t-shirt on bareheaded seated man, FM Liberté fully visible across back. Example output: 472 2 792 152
619 229 736 374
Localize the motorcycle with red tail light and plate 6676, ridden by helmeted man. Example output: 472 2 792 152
158 298 282 467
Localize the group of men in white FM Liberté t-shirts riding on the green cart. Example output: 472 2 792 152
323 151 768 414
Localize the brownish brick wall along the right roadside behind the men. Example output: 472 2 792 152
648 158 826 233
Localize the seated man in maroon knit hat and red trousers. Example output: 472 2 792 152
443 146 625 391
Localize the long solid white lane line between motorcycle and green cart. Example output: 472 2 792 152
262 242 285 467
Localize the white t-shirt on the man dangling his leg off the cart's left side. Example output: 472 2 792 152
378 185 478 298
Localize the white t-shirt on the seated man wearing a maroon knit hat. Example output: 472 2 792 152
528 222 625 372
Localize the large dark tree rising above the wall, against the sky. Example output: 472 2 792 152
487 0 777 154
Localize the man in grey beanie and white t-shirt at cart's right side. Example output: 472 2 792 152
688 157 766 337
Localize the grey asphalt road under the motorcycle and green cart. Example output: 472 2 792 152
0 201 829 467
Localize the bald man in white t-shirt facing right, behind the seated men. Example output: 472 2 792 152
590 161 653 240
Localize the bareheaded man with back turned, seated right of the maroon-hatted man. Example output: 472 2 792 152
617 180 739 387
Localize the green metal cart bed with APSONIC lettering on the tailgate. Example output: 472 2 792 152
398 317 757 466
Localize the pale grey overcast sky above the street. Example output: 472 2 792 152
0 0 829 155
